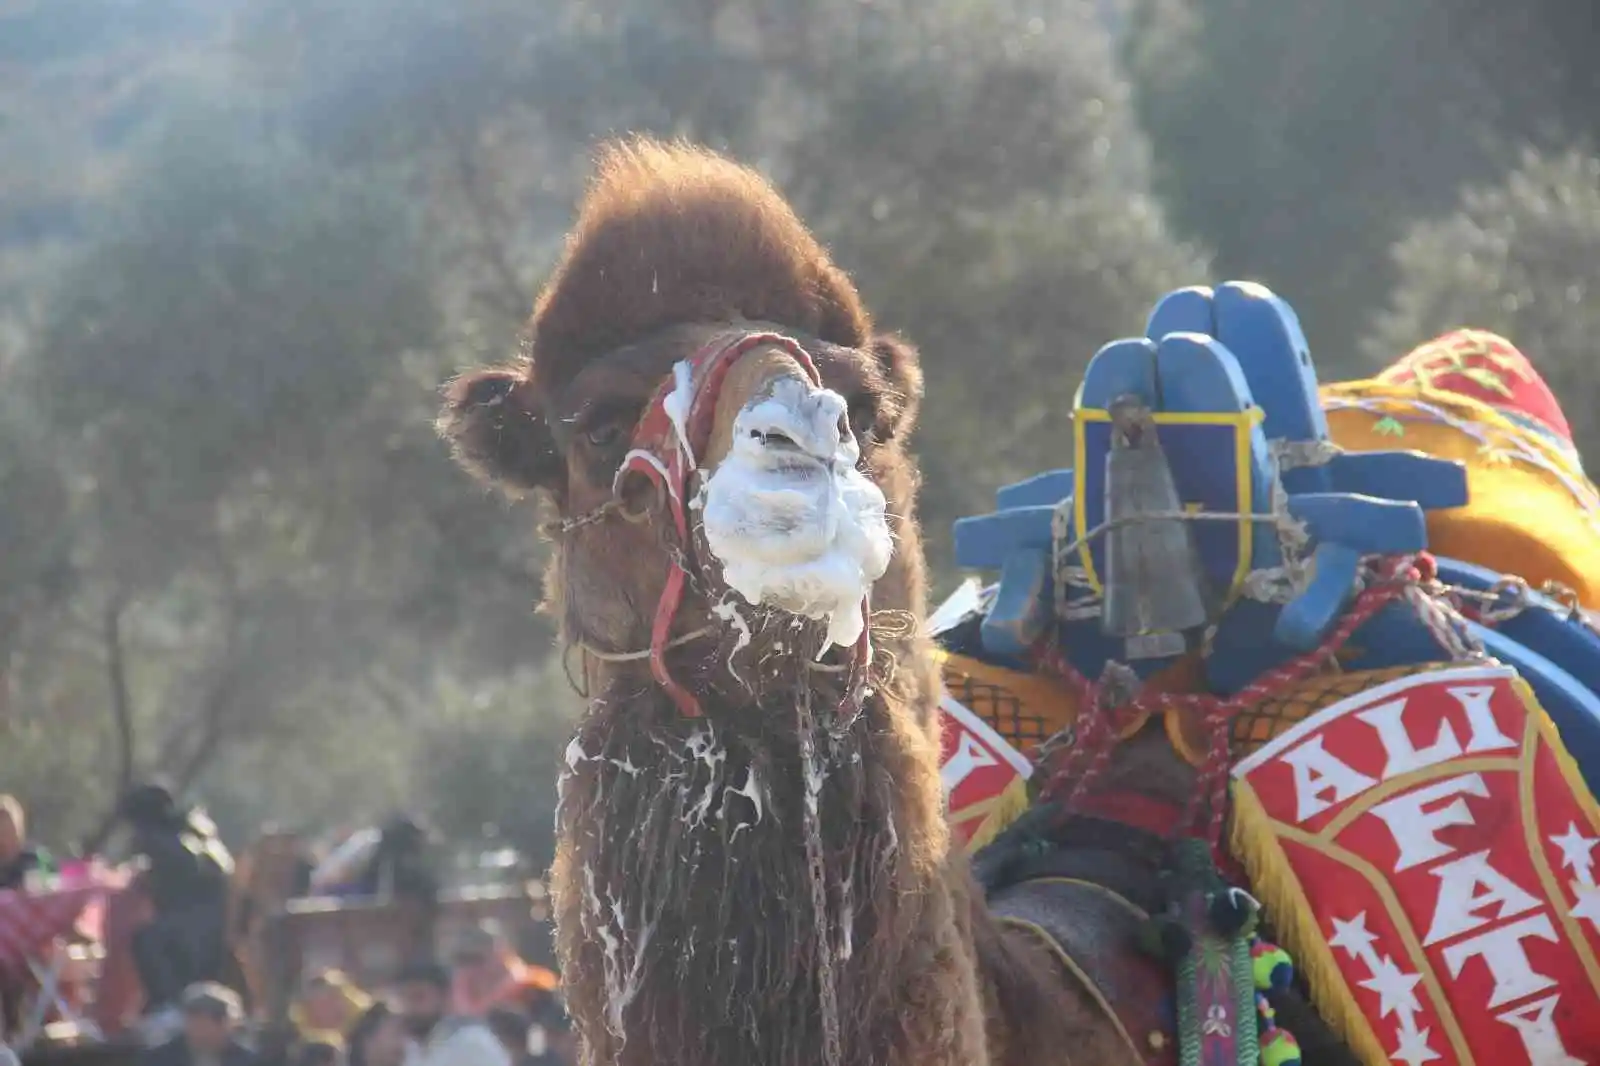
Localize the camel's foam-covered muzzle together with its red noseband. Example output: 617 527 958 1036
614 333 893 717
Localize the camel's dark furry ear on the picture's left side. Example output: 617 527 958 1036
437 368 563 498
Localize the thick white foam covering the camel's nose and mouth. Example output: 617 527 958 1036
702 378 893 650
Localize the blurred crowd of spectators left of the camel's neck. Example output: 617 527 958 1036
0 784 578 1066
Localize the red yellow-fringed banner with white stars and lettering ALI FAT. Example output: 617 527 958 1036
1234 667 1600 1066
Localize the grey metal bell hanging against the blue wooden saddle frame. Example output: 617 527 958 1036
1101 397 1210 659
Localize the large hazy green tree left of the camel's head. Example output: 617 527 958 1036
6 109 547 845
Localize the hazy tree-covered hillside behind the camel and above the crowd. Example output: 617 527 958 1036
0 0 1600 861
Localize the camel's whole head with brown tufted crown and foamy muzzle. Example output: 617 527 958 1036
440 141 923 714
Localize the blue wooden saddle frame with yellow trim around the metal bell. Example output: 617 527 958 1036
955 283 1466 675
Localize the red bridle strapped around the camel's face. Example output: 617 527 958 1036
547 330 872 717
